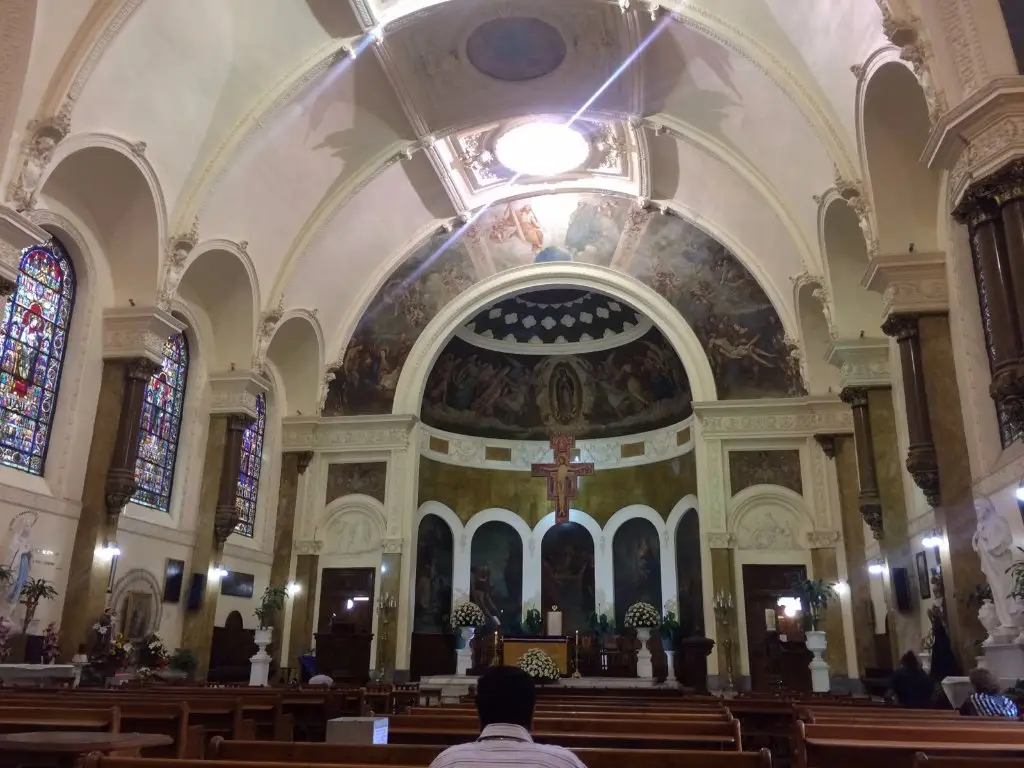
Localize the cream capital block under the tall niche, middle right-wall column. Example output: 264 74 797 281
860 253 949 317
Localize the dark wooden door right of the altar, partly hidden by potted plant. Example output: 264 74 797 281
743 565 807 693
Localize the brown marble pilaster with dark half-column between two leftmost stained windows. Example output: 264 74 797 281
60 357 159 657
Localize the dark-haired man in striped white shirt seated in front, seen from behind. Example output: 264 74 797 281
430 667 587 768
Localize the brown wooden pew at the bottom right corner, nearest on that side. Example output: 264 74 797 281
794 721 1024 768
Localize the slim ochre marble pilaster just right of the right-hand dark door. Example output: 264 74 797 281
819 434 878 675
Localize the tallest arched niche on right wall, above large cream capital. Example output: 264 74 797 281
862 62 940 255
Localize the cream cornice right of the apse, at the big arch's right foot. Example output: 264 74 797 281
693 396 853 439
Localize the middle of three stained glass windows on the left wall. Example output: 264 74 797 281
131 334 188 512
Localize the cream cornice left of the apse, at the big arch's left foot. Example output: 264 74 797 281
282 414 418 453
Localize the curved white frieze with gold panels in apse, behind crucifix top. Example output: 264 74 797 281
419 418 693 472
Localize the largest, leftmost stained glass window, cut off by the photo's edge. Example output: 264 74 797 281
0 241 75 475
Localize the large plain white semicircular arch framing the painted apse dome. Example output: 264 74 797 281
392 263 718 415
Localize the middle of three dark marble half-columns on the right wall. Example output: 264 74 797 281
882 314 940 507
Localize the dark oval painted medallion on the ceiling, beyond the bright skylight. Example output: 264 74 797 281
466 16 566 83
